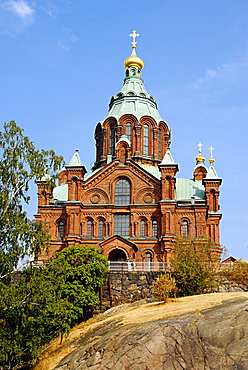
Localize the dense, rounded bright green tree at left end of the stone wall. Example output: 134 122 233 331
42 245 108 320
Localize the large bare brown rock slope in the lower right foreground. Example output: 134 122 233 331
54 293 248 370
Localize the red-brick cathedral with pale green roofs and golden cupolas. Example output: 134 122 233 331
35 31 222 262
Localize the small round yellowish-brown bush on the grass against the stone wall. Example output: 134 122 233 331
152 273 177 302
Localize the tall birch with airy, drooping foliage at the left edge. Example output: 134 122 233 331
0 121 63 279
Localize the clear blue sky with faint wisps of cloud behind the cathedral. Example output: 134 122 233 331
0 0 248 260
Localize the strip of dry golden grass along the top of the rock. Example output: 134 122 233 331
33 292 248 370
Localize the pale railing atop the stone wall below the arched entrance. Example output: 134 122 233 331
108 261 169 272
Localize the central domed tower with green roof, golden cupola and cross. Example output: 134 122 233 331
93 30 170 170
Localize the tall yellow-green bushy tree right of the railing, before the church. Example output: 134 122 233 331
170 238 216 295
